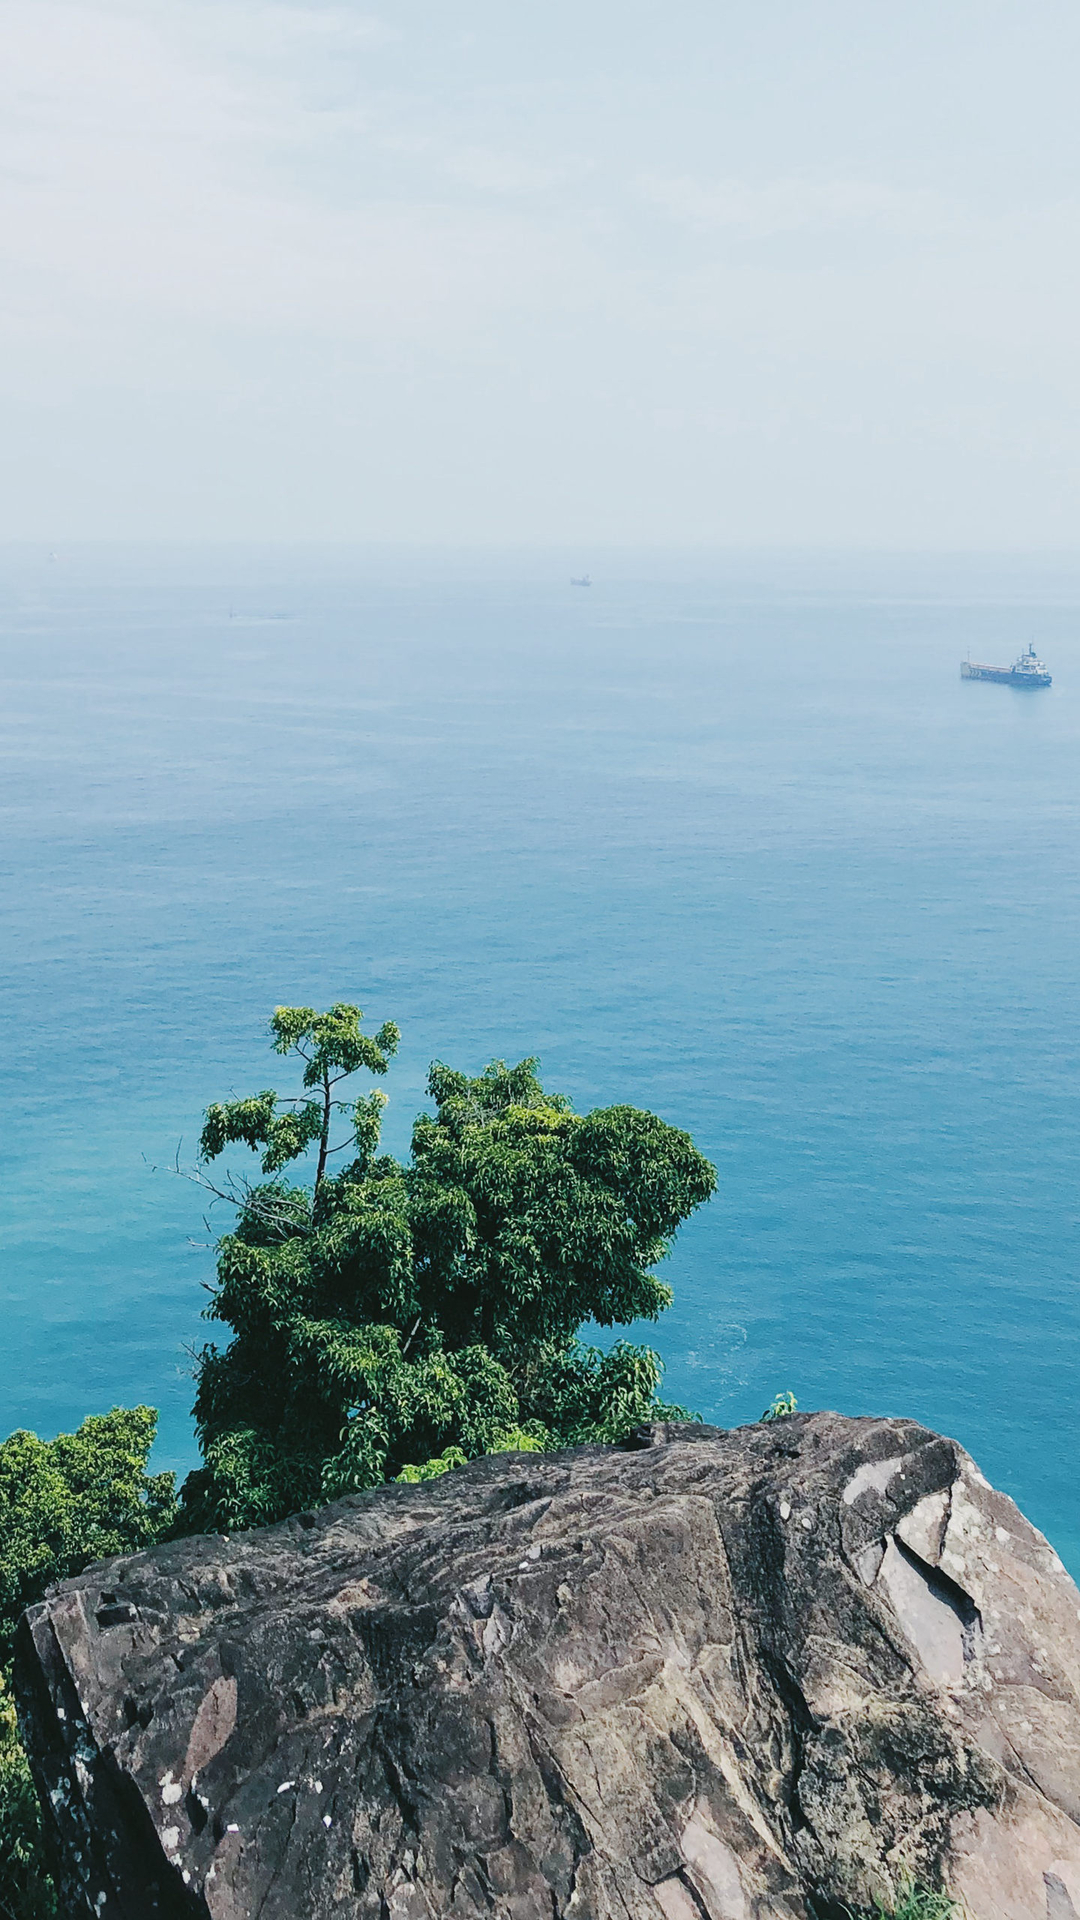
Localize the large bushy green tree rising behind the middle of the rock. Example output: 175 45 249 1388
184 1004 715 1528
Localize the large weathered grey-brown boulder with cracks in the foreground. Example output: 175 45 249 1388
17 1413 1080 1920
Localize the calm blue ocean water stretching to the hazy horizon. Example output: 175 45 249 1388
0 549 1080 1572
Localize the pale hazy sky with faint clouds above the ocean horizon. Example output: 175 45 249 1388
0 0 1080 559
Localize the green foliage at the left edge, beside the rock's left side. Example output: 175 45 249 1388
0 1407 177 1920
